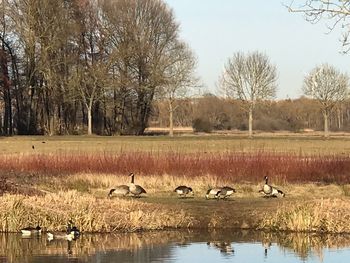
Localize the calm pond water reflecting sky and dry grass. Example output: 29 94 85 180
0 230 350 263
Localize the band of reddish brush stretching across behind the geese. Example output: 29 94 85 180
0 152 350 183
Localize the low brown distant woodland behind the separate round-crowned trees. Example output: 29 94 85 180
150 94 350 132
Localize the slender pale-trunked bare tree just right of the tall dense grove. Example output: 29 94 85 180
160 43 198 137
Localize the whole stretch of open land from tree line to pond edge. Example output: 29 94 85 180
0 135 350 233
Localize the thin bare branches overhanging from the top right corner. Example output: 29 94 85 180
286 0 350 53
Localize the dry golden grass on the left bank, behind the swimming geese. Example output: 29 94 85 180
0 191 192 232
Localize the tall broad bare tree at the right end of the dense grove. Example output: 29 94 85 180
100 0 178 134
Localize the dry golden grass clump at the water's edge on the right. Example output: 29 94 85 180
260 198 350 233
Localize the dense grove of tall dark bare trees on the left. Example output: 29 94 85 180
0 0 195 135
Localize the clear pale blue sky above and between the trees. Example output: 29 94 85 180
165 0 350 99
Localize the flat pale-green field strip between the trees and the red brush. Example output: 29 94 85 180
0 133 350 156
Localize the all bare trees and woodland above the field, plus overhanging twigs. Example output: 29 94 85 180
0 0 349 136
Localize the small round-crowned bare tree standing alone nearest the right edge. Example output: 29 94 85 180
303 64 349 137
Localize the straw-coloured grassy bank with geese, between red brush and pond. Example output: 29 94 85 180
0 173 350 233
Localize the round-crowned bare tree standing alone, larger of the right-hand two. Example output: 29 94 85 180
220 51 277 137
